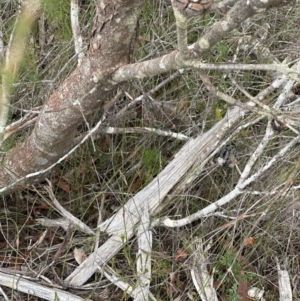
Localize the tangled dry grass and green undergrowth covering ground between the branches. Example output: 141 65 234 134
0 0 300 300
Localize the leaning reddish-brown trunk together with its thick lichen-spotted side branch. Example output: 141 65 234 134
0 0 285 187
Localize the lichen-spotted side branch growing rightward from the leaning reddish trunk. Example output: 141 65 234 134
111 0 294 83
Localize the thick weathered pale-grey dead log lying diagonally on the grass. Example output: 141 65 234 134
66 72 286 286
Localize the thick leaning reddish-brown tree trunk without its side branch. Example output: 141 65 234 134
0 0 144 187
